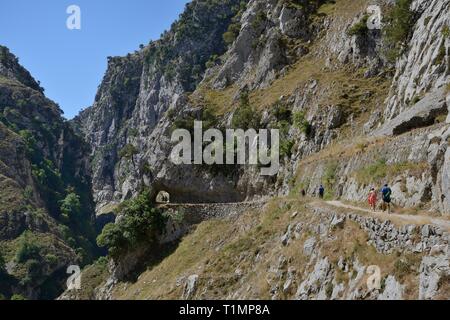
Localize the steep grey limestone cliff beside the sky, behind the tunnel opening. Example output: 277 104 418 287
77 1 256 211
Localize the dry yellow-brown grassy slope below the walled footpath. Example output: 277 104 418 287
114 199 428 299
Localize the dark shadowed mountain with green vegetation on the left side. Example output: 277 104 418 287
0 46 97 299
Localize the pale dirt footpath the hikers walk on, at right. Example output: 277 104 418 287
325 200 450 231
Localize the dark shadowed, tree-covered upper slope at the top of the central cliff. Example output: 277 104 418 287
145 0 247 91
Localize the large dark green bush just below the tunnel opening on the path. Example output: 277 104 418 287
97 191 167 257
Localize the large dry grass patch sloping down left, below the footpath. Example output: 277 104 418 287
115 200 312 299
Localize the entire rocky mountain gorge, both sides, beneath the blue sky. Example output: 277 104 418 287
0 0 450 299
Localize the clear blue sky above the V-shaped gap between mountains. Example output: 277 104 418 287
0 0 189 119
